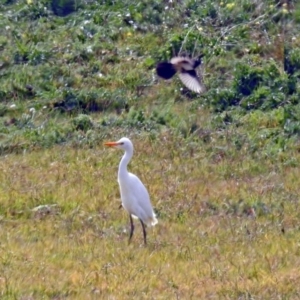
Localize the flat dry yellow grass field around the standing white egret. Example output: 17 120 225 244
0 134 300 299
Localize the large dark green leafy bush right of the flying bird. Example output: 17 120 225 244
206 61 298 111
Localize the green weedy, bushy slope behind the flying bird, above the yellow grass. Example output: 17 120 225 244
0 0 300 152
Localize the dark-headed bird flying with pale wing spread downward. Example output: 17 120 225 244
156 55 205 94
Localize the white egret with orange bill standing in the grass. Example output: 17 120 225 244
104 137 157 245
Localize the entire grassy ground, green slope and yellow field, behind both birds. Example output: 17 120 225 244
0 1 300 299
